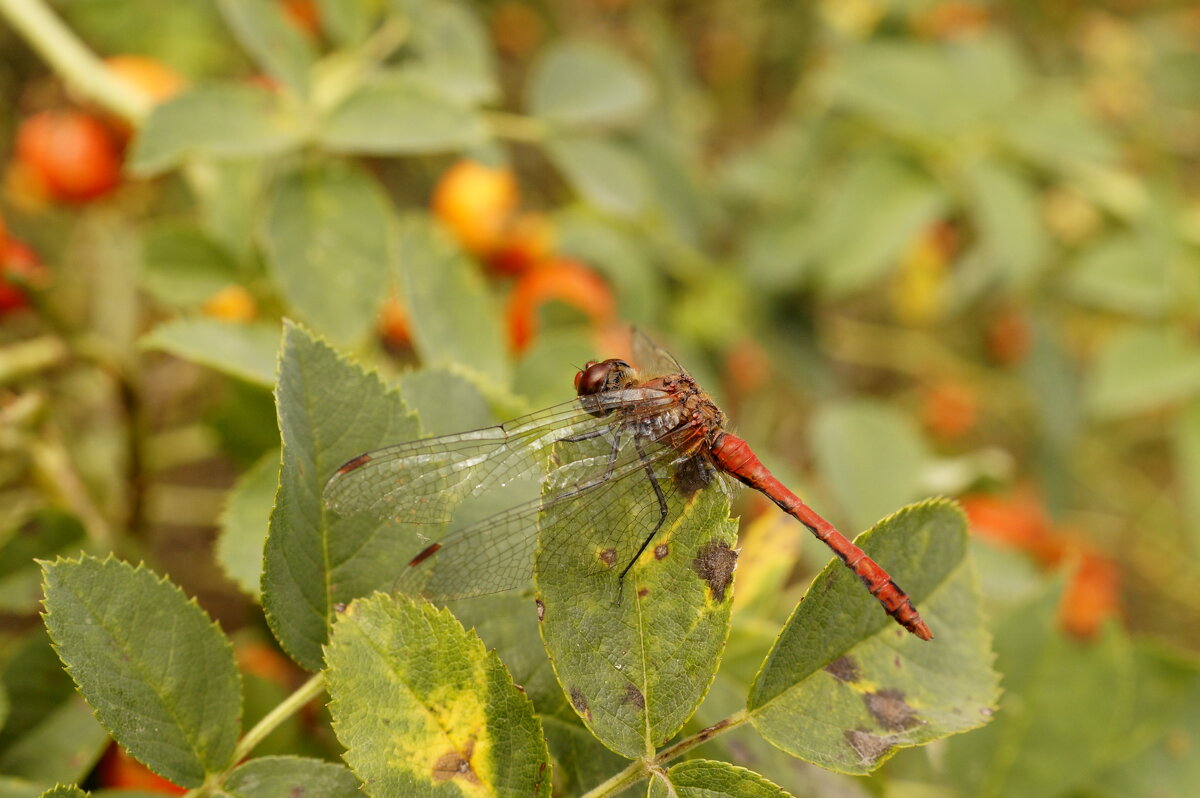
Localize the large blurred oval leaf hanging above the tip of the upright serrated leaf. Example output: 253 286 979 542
263 163 395 344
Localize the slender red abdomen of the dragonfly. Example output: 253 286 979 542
710 433 934 640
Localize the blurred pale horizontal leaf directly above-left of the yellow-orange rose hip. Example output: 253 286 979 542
318 73 488 155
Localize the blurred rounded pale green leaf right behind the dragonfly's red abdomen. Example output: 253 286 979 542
809 398 929 530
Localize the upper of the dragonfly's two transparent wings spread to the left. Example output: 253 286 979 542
324 388 672 524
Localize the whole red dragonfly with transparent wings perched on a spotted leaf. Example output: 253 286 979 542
324 330 932 640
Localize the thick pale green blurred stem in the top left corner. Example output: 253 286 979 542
0 0 150 122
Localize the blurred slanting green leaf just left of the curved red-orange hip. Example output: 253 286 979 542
400 216 512 394
